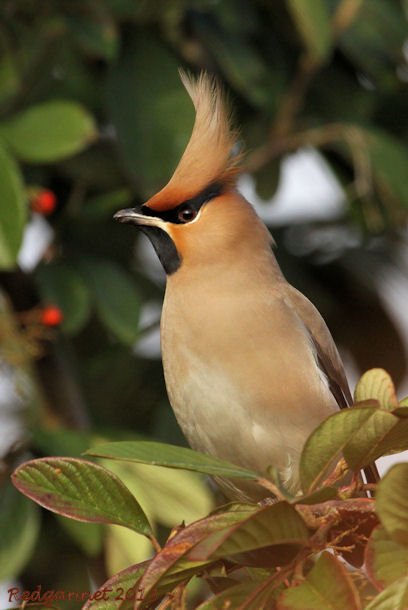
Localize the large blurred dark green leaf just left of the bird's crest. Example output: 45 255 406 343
107 30 194 198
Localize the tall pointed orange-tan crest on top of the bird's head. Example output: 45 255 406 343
146 71 240 211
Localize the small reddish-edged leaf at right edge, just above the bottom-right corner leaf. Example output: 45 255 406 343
365 526 408 589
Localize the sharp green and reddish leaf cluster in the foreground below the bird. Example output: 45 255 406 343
12 369 408 610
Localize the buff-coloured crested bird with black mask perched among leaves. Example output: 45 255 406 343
115 72 378 502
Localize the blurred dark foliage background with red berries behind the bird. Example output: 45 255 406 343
0 0 408 608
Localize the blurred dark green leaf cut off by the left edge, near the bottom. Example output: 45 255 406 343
0 482 40 580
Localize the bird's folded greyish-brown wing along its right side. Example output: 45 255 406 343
287 284 380 483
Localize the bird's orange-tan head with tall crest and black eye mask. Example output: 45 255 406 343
114 73 270 275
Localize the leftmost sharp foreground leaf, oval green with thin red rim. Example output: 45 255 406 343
12 458 151 535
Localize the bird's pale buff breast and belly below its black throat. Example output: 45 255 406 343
162 235 338 499
